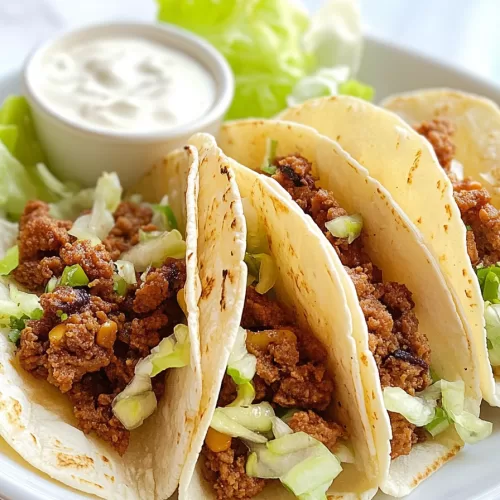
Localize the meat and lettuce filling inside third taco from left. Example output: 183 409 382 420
256 150 491 459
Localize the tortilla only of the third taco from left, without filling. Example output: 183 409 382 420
220 120 481 496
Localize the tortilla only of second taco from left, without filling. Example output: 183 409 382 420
179 134 380 500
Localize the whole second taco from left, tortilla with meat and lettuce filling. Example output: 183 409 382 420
179 134 379 500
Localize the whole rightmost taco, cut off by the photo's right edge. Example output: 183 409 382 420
283 94 500 406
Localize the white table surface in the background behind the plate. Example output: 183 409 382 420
0 0 500 85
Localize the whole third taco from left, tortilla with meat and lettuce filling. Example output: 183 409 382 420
220 121 491 496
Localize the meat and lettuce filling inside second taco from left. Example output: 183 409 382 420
203 199 346 499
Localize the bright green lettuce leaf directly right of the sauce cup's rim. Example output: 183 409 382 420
157 0 312 119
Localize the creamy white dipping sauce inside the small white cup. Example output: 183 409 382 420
36 37 216 132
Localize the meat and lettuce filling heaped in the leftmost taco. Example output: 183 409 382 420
0 174 189 454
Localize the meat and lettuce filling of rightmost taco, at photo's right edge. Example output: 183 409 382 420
414 118 500 376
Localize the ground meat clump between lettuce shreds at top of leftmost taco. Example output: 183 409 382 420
103 201 157 260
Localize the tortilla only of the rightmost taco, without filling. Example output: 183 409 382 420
283 94 500 406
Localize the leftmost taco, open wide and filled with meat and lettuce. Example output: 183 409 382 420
0 148 201 499
